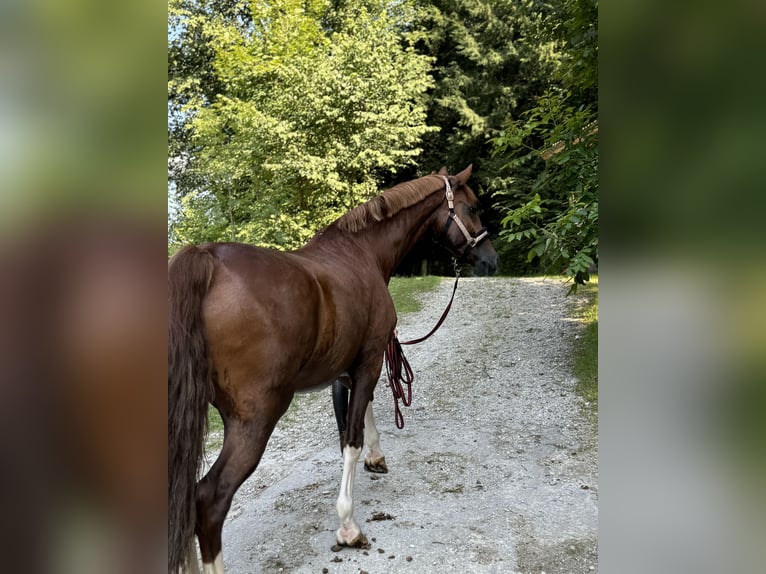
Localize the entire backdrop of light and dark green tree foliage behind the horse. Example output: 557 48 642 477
168 0 598 286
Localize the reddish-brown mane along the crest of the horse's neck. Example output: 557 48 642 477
335 175 444 233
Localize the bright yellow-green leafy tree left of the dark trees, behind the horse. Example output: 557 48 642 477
169 0 432 252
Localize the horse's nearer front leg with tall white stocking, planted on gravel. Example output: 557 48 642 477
335 352 383 547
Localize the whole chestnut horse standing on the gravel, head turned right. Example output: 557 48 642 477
168 166 497 574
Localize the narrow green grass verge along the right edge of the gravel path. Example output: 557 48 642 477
572 276 598 406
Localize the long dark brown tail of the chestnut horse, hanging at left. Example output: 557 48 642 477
168 246 215 574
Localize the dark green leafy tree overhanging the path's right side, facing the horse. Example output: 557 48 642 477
492 0 598 289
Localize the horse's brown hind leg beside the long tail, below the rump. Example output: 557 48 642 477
196 399 290 574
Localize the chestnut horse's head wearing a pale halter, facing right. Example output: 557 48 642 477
433 165 497 275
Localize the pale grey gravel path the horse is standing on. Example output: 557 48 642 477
204 278 598 574
